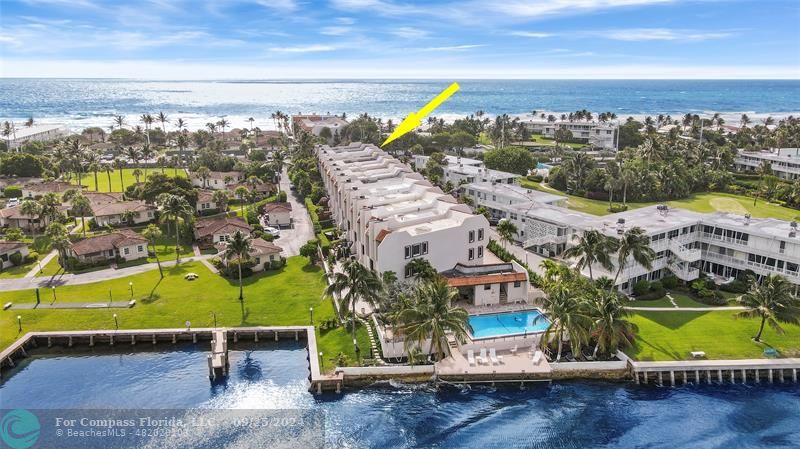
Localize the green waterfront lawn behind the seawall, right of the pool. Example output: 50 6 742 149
626 311 800 361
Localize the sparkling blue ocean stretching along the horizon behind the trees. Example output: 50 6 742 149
0 78 800 129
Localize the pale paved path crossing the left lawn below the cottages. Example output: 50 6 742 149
0 255 214 290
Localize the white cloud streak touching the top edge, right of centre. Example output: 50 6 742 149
491 0 673 17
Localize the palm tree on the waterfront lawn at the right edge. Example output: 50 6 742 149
734 274 800 341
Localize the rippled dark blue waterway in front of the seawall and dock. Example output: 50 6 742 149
0 342 800 449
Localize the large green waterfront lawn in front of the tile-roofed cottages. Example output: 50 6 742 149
0 257 369 369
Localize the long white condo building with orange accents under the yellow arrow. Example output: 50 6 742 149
316 143 528 304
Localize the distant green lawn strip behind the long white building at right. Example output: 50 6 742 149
520 179 800 220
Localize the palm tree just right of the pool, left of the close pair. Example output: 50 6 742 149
541 283 591 362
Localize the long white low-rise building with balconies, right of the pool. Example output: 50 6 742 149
464 185 800 292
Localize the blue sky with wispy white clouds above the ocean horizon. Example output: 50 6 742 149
0 0 800 79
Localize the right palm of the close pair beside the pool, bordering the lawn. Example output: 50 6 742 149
589 290 638 358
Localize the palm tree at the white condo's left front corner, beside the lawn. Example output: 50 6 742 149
325 259 383 340
